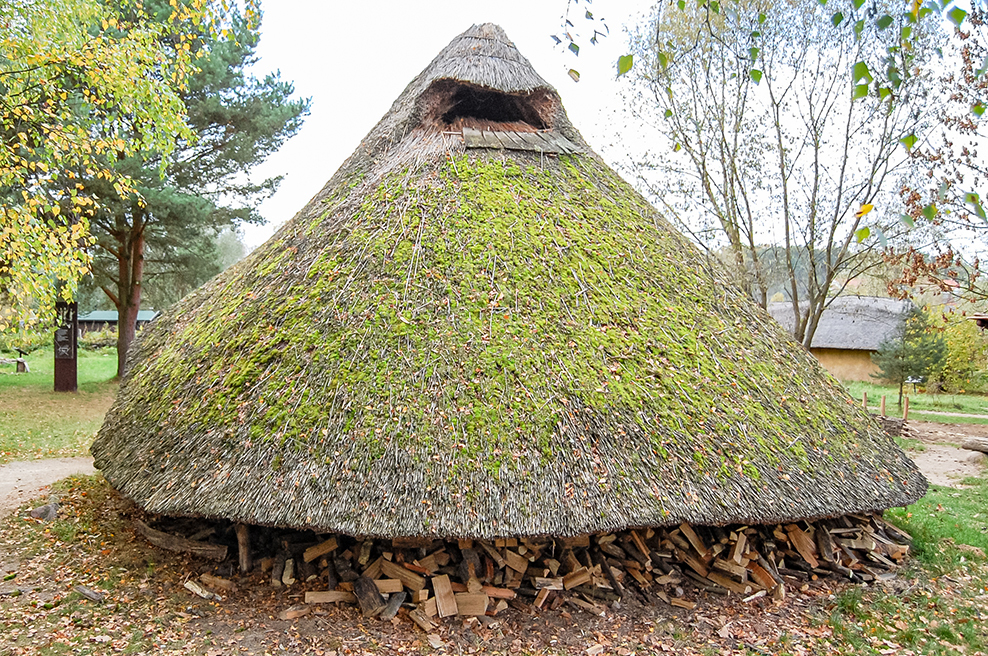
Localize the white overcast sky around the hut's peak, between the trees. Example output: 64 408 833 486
244 0 651 248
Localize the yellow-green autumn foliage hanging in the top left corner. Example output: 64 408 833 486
0 0 257 330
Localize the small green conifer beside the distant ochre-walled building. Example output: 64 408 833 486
871 308 947 407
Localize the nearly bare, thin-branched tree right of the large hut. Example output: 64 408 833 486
631 0 935 345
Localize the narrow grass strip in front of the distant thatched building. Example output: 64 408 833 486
844 381 988 424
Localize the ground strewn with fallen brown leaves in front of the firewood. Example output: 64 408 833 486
0 477 988 656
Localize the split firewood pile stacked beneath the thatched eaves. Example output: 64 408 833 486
139 515 911 620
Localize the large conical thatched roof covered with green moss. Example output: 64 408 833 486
93 25 926 537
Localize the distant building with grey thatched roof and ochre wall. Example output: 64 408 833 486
768 296 916 382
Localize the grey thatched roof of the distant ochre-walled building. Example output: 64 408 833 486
768 296 915 351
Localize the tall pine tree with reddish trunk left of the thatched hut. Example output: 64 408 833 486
85 7 309 375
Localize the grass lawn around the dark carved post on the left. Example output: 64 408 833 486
0 349 117 464
